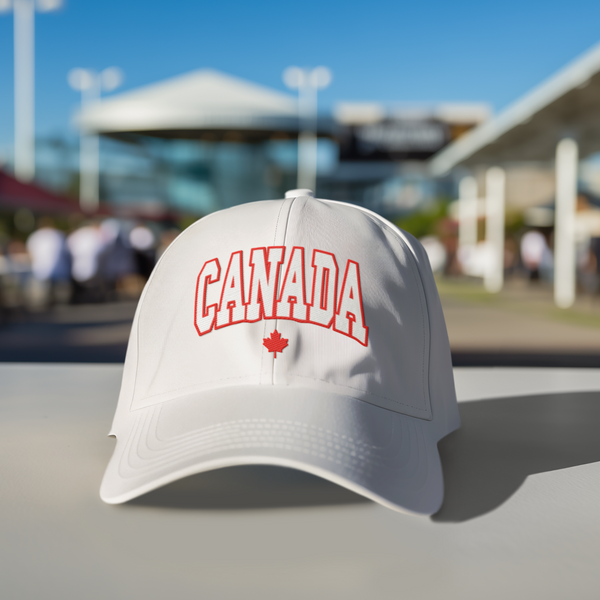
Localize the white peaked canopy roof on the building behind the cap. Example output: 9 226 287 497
76 69 298 140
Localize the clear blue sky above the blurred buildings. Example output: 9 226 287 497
0 0 600 149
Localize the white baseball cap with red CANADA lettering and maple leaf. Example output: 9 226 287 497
100 190 460 514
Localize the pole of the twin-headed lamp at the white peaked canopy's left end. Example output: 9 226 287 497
79 73 101 213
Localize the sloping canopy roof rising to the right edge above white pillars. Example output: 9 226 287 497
430 44 600 175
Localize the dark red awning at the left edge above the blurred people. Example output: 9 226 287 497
0 171 81 213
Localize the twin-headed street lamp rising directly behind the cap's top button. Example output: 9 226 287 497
283 67 332 191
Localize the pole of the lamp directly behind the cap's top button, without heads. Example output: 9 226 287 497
297 80 317 191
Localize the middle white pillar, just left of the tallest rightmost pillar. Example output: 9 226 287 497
483 167 506 293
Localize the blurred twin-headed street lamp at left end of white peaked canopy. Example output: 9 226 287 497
67 67 123 212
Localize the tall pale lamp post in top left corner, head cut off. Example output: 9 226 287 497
0 0 62 181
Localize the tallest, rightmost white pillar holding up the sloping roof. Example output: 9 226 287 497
554 138 578 308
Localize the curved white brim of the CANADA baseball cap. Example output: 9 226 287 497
100 386 443 515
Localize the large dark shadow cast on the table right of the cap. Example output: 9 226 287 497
431 392 600 522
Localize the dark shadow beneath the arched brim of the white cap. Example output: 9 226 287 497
124 465 371 510
